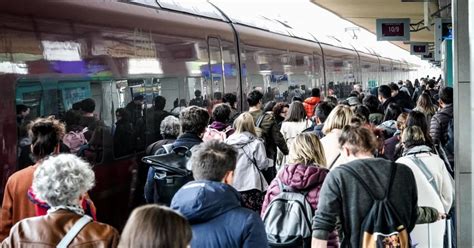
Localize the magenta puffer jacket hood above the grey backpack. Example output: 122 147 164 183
279 164 329 190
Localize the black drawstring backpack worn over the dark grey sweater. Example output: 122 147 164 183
341 163 411 248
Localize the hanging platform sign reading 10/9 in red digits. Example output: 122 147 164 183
376 18 410 41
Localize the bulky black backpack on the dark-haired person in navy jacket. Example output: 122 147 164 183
142 147 193 206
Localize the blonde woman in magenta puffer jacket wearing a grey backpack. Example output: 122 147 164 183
261 132 338 247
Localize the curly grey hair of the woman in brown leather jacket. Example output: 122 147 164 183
32 154 95 207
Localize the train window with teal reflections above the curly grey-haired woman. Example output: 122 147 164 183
16 80 110 168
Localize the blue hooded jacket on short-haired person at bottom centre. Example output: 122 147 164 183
171 181 268 248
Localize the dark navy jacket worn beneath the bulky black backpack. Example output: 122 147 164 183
145 133 202 203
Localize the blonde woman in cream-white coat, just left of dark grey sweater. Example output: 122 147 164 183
321 105 353 170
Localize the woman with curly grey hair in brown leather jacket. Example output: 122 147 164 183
2 154 119 247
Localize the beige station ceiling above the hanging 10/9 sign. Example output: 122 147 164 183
310 0 451 50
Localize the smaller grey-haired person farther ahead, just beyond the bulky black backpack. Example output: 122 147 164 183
146 115 181 155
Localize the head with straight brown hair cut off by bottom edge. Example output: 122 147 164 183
118 205 192 248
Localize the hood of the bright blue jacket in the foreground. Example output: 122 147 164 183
171 180 241 225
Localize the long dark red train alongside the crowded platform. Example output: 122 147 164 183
0 0 417 228
